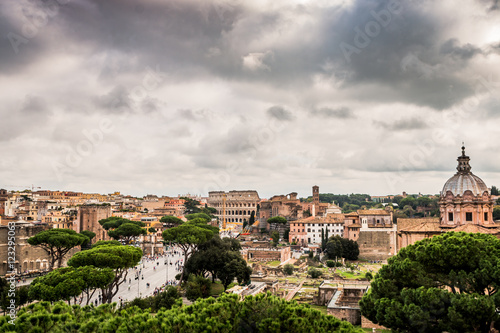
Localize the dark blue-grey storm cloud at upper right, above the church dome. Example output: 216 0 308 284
331 1 480 109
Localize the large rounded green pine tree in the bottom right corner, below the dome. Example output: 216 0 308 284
360 232 500 333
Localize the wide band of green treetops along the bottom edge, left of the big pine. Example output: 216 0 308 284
0 294 363 333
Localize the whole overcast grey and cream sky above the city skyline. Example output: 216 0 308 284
0 0 500 198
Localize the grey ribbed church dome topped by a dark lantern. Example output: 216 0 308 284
441 147 488 196
